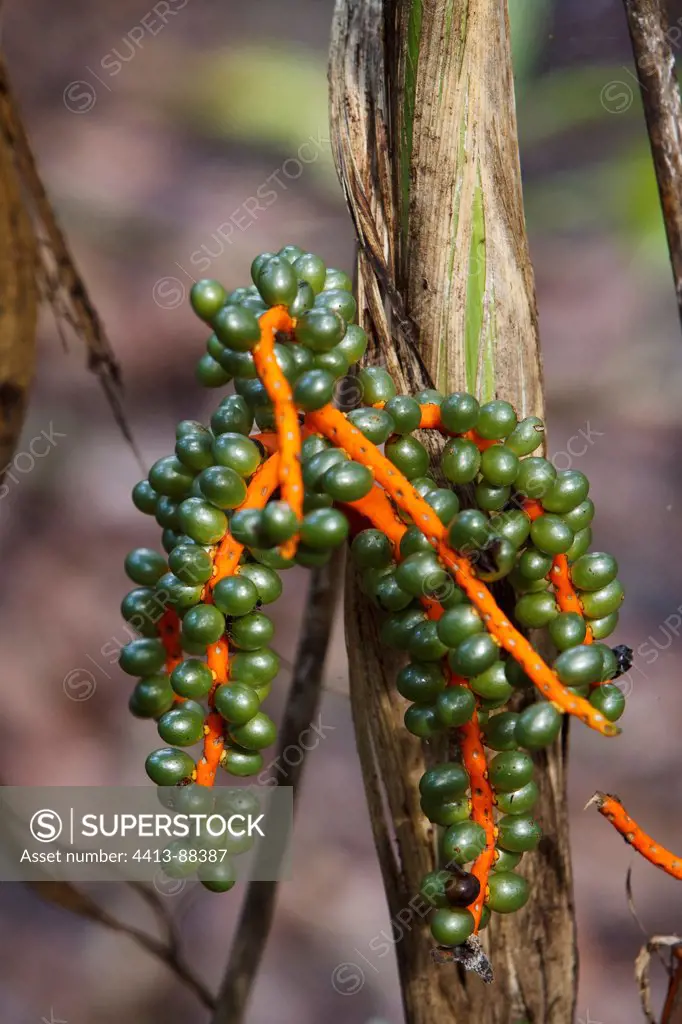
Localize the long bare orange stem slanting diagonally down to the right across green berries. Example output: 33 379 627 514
307 406 621 736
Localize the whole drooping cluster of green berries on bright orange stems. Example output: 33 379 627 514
115 246 627 929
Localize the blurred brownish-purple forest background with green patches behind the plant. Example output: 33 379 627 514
0 0 682 1024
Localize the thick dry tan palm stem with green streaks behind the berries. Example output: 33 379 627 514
330 0 577 1024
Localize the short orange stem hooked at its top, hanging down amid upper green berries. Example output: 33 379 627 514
253 306 303 558
